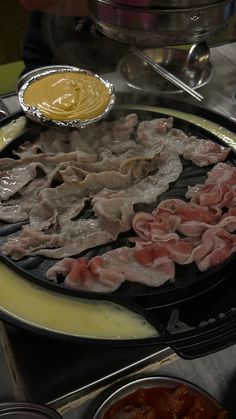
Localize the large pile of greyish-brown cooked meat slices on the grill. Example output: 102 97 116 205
0 114 229 264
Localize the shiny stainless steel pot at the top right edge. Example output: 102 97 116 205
89 0 235 47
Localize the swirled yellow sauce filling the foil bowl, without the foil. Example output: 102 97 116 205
24 71 111 121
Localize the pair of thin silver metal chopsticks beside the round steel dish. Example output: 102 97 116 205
131 47 204 102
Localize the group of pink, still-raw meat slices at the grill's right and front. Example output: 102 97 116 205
47 165 236 292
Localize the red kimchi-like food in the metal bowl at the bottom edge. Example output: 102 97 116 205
102 384 228 419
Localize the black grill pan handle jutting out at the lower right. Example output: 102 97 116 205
162 314 236 359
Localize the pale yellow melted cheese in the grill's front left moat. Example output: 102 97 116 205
0 263 159 339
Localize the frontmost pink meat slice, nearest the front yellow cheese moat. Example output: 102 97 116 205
47 247 175 292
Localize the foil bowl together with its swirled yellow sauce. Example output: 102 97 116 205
19 67 115 128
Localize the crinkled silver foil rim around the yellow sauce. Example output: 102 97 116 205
18 66 115 128
